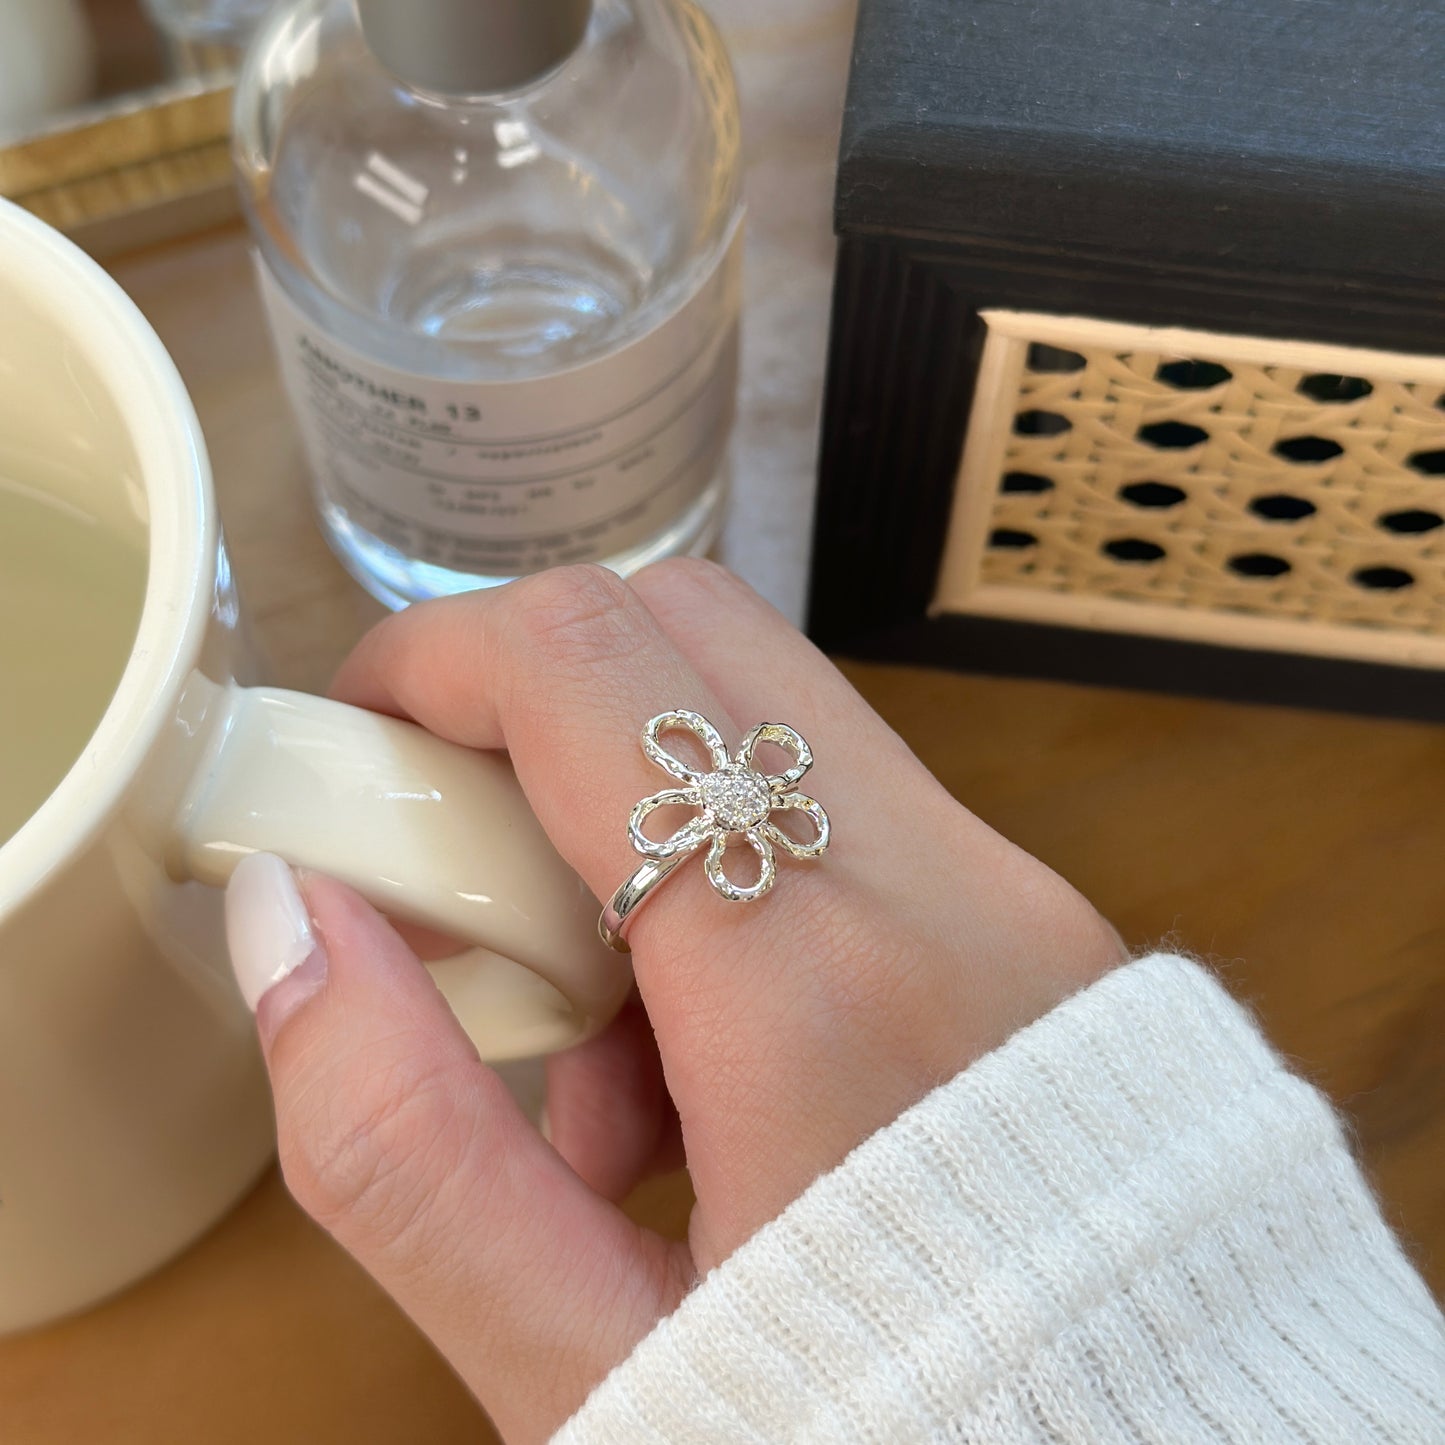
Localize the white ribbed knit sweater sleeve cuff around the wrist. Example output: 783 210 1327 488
555 955 1445 1445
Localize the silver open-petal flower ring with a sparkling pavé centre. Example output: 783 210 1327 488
598 709 829 951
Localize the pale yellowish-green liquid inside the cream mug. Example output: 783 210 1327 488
0 477 146 844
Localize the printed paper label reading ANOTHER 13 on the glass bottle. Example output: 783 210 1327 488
257 225 743 575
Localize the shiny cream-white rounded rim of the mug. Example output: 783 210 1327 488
0 199 220 919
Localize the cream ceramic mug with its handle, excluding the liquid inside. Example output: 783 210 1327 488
0 202 630 1331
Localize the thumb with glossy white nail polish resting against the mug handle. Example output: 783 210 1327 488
227 854 691 1442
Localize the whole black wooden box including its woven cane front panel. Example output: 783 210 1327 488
809 0 1445 718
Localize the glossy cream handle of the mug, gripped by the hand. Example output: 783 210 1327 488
166 673 631 1061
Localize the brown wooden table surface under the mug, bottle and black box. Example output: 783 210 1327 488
0 0 1445 1445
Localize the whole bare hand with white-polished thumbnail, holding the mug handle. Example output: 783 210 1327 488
231 562 1124 1442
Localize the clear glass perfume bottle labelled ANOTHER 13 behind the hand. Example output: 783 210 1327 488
234 0 741 607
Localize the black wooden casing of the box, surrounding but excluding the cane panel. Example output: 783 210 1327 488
808 0 1445 720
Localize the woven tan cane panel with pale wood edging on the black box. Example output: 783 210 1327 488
935 312 1445 666
